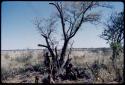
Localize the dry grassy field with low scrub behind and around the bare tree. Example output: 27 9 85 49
1 48 124 83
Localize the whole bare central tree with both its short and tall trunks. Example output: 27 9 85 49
36 1 109 82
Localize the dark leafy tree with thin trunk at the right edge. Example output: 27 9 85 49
101 12 124 81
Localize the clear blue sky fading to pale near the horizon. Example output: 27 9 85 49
1 1 124 50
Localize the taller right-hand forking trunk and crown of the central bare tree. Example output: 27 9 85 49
50 2 99 66
